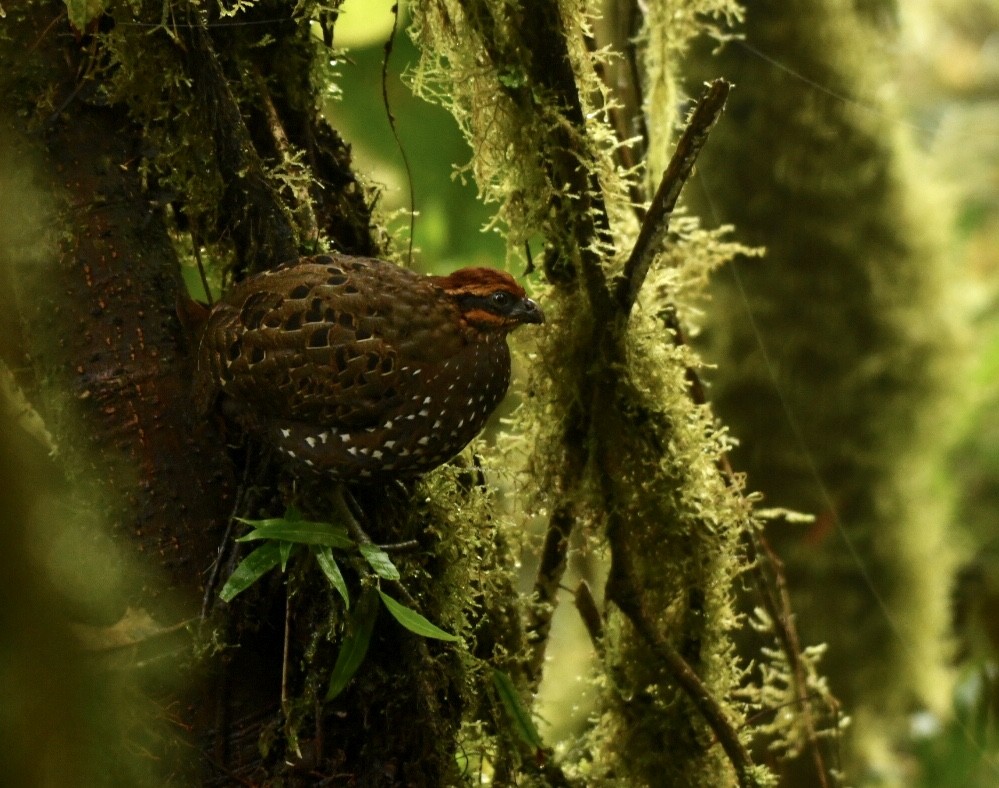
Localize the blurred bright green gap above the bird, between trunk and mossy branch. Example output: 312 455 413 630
325 0 506 273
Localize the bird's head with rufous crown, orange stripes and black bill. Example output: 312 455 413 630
434 268 545 332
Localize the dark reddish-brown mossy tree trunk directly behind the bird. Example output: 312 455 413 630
0 0 484 785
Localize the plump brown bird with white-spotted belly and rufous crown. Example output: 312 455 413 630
197 255 544 479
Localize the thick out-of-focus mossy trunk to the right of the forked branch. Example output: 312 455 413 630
691 0 955 771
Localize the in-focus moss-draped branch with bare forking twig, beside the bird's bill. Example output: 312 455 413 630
416 2 788 785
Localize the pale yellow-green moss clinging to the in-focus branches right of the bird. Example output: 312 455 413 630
406 2 804 786
